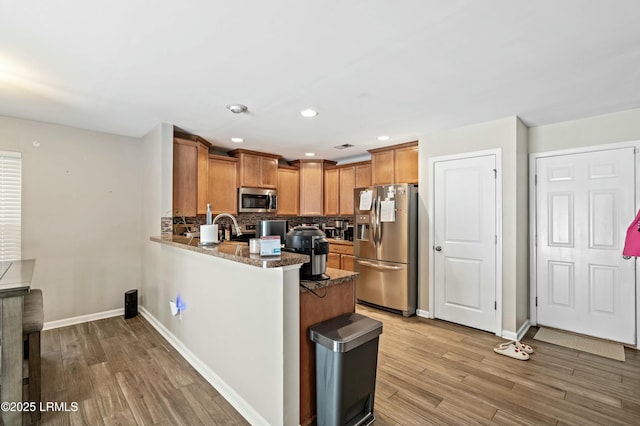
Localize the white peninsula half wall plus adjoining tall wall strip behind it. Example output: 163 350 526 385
140 124 300 425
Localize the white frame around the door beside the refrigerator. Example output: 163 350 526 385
427 148 502 336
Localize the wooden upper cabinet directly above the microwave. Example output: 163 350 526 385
229 149 280 189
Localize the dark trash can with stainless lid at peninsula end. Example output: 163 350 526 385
310 313 382 426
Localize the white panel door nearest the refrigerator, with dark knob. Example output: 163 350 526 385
433 155 496 332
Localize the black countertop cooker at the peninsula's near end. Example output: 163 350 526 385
285 226 329 281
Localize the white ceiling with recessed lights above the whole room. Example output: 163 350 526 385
0 0 640 161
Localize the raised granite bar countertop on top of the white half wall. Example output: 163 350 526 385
150 235 309 268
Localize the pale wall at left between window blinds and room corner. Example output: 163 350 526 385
0 117 142 322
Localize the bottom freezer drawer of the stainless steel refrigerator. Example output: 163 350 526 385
355 259 416 316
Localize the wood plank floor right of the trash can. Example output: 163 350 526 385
356 305 640 426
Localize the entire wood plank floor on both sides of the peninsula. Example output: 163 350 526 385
36 305 640 426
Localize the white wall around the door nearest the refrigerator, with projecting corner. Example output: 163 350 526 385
418 117 528 333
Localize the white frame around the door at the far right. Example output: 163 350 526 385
529 140 640 349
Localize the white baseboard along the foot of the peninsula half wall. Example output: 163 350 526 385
139 307 269 426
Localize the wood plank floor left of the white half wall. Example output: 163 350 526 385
35 316 247 425
